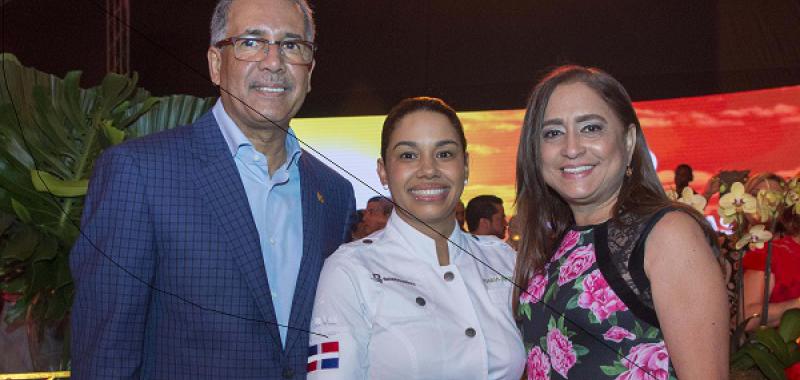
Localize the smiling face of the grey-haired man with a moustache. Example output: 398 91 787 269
208 0 313 137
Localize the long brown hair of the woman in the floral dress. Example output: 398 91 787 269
514 65 714 315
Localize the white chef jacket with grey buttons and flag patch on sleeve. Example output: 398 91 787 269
308 213 525 380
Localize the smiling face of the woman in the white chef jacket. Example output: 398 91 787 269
378 110 467 236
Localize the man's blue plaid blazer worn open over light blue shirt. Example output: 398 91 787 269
70 112 355 379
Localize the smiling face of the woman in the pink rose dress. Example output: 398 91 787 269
538 82 636 224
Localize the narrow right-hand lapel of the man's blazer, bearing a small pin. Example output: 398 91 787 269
286 151 330 352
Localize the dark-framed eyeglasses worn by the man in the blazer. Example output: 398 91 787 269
214 37 317 65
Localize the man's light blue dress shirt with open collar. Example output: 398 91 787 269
212 100 303 347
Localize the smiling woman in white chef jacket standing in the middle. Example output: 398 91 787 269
308 97 525 380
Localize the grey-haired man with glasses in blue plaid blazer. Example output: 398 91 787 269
70 0 355 379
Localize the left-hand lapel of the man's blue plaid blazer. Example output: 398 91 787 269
193 112 282 352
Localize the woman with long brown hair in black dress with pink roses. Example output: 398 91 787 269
515 66 728 379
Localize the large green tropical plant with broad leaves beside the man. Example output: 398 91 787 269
0 54 213 366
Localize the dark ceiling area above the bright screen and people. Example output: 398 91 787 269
2 0 800 116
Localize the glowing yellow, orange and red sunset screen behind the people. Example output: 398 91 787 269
292 86 800 214
